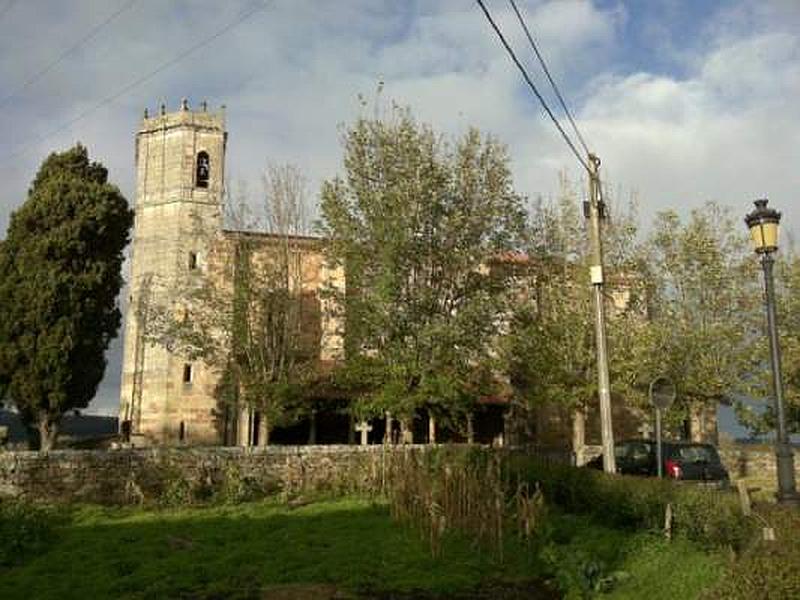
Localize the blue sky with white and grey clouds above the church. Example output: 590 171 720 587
0 0 800 410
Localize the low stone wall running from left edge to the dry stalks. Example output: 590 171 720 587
0 446 404 504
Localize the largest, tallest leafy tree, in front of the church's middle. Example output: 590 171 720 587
321 108 525 432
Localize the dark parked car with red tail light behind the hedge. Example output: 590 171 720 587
586 440 729 486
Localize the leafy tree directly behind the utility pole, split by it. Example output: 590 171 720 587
503 175 644 446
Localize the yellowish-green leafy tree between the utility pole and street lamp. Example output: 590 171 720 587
637 203 759 439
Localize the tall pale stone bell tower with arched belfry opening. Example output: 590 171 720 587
119 100 227 445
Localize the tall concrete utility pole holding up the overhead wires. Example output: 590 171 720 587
586 154 617 473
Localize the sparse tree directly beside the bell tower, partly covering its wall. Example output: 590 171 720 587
148 165 320 443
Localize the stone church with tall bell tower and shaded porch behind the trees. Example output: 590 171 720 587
119 100 715 453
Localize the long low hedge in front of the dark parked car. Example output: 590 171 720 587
509 456 756 550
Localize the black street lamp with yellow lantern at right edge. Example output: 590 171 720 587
744 198 800 504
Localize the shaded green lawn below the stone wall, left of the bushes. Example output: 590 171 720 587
0 500 544 600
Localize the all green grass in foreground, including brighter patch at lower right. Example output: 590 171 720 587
0 500 721 600
